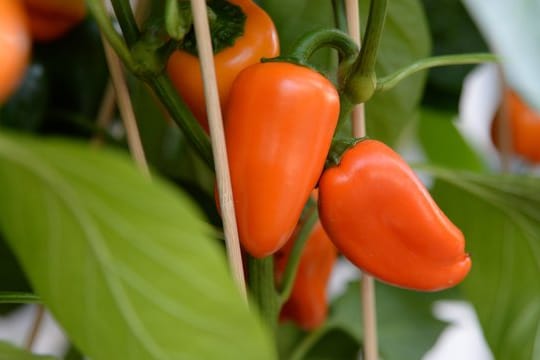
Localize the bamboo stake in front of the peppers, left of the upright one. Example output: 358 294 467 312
191 0 247 301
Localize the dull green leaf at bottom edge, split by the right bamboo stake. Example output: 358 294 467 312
280 281 447 360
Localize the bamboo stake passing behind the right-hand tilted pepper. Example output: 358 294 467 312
345 0 379 360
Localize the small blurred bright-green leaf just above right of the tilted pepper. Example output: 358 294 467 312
418 109 486 171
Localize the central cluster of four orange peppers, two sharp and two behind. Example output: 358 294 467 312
167 0 471 329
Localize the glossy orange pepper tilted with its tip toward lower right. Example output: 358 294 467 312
319 140 471 291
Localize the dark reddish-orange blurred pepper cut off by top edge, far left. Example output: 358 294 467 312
23 0 86 42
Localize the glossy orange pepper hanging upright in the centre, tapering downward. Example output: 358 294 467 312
224 62 339 258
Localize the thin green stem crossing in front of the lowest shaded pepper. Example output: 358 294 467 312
279 201 319 307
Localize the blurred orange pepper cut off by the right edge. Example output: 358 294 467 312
491 89 540 164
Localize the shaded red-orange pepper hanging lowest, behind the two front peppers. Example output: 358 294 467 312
274 221 337 330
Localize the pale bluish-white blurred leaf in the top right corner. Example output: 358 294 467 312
462 0 540 110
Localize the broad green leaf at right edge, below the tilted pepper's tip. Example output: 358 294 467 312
427 168 540 359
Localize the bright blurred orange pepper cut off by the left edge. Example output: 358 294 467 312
0 0 32 104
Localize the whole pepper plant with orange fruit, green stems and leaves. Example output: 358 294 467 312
0 0 540 359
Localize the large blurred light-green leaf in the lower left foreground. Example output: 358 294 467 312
0 133 274 360
